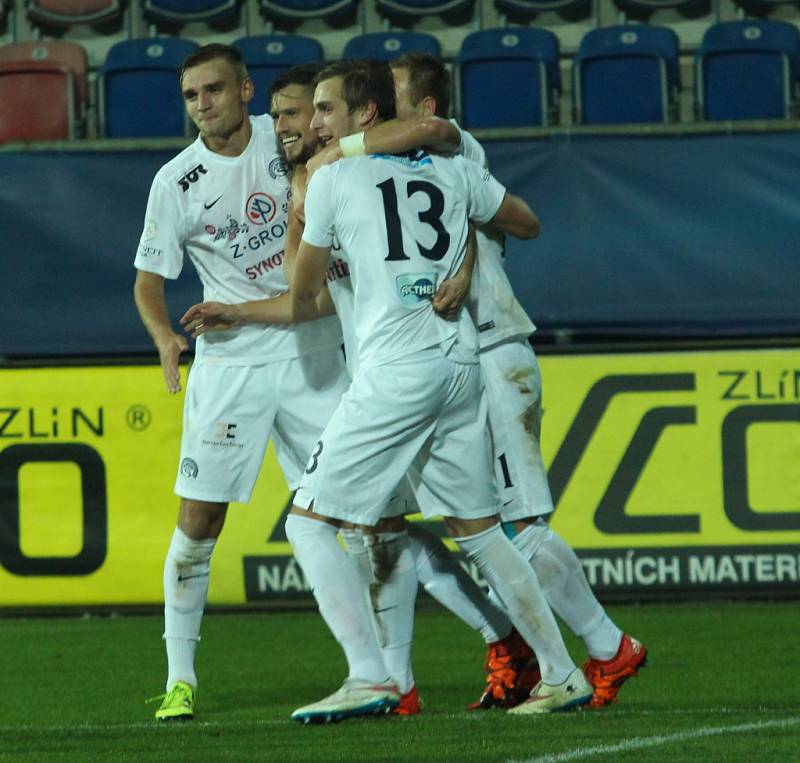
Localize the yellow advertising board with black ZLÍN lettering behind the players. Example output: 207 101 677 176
0 350 800 607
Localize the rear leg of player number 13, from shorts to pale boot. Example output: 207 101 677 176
415 364 591 712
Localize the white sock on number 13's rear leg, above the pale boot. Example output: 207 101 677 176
453 524 575 686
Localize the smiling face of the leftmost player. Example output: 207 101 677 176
181 58 253 138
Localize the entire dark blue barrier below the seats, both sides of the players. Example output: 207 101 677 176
0 133 800 357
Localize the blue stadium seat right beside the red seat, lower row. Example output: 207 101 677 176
98 37 197 138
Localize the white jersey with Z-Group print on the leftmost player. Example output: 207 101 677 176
134 115 341 365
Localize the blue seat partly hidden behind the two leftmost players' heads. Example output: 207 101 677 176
233 34 323 114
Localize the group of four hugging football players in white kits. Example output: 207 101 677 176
134 44 647 723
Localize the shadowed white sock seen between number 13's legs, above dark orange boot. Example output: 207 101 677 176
408 522 511 644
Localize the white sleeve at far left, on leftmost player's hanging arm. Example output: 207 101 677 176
133 177 184 278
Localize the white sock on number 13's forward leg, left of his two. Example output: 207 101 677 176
286 514 389 682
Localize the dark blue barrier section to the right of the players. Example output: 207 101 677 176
486 133 800 338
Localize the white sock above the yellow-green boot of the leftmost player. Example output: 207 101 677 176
164 527 217 691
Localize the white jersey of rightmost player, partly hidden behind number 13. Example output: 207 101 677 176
453 121 536 350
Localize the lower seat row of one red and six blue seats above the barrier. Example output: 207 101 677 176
0 21 800 142
